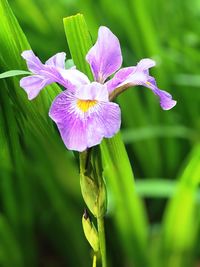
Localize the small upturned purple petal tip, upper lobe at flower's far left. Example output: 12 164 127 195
21 50 43 74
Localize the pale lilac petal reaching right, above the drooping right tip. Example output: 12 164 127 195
106 58 156 93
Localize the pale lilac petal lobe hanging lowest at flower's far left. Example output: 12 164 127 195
20 75 50 100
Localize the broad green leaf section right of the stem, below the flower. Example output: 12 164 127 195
102 133 148 266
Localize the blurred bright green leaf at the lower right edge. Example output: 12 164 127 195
162 145 200 267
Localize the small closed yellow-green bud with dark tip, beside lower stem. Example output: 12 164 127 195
82 210 99 252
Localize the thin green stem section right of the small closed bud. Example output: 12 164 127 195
97 217 107 267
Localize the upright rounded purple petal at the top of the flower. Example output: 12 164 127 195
86 26 122 83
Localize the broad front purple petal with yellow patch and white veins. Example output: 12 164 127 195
49 84 121 152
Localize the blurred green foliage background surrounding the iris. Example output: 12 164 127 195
0 0 200 267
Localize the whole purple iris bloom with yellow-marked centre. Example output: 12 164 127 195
20 26 176 152
